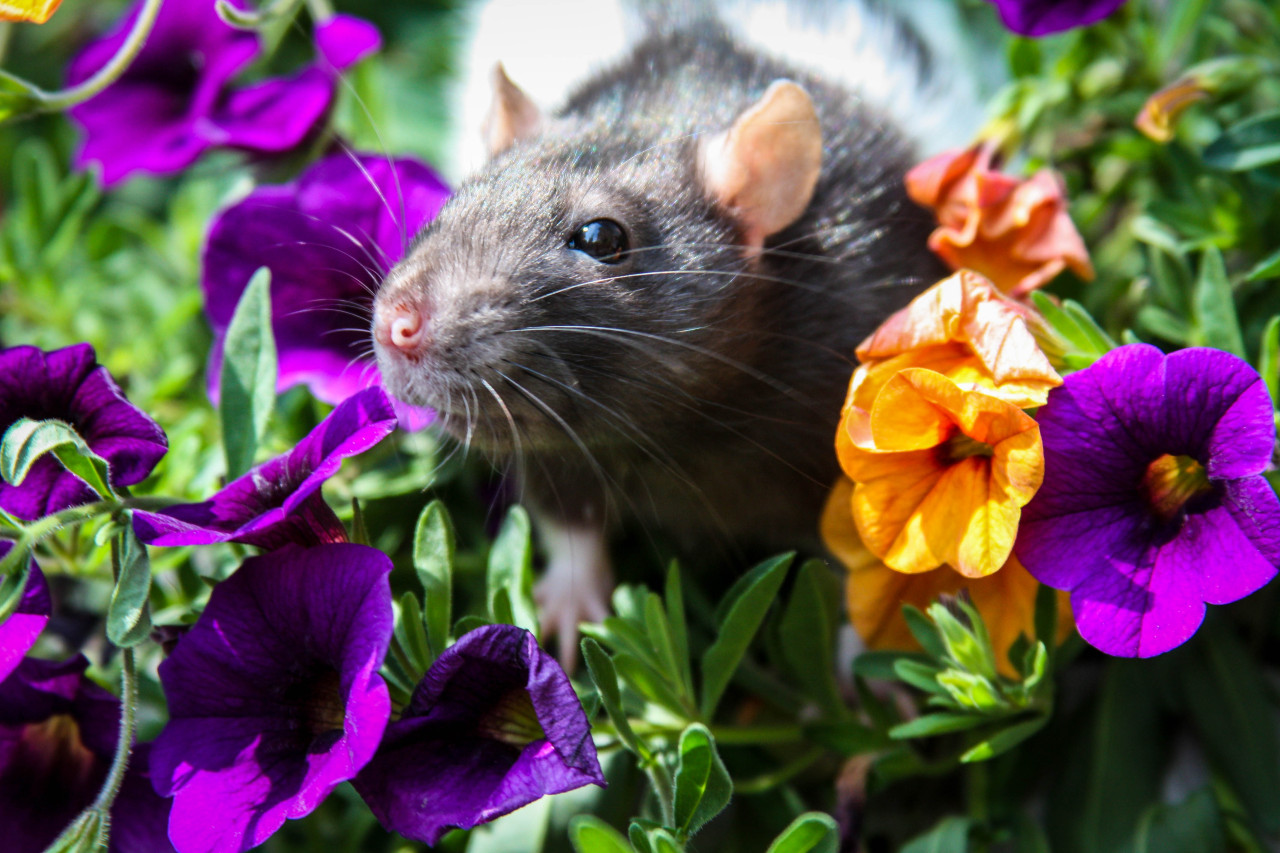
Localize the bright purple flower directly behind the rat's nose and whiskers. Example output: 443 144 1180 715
202 154 448 429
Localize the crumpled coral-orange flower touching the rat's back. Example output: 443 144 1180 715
906 143 1093 297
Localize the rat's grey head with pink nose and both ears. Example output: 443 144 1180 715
374 68 822 450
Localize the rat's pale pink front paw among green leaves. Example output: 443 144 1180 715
534 528 613 671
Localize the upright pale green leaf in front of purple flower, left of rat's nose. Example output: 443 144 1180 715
218 266 276 479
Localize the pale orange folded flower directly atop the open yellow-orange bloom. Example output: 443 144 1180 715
845 270 1062 411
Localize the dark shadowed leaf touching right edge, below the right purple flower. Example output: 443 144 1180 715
1174 620 1280 833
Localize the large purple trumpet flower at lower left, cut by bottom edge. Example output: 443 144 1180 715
151 543 392 853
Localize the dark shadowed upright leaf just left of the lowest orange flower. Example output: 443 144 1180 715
778 560 846 717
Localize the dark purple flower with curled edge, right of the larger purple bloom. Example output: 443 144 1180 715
355 625 604 844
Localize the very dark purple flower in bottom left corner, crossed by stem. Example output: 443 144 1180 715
0 656 173 853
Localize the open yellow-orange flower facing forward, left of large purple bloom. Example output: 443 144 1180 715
836 368 1044 578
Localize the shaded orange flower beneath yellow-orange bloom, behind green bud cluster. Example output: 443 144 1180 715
822 478 1073 678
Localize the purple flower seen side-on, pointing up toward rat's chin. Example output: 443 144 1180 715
133 388 396 549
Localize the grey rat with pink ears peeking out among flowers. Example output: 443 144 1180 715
372 0 967 661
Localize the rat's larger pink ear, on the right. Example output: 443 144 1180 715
698 79 822 248
